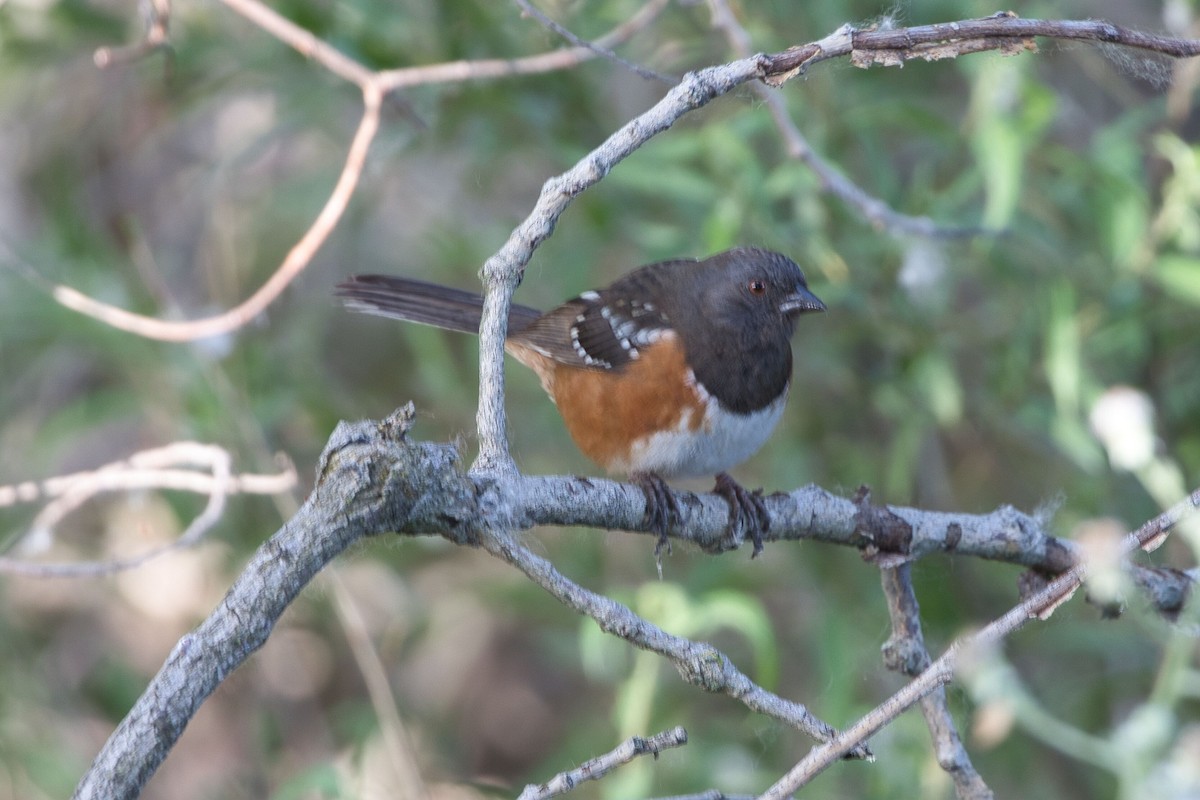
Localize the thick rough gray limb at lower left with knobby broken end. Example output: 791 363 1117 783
73 407 456 800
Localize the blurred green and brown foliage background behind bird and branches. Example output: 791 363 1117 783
0 0 1200 800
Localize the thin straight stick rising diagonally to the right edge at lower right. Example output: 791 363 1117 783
761 489 1200 800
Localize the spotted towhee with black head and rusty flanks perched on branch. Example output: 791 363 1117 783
337 247 824 555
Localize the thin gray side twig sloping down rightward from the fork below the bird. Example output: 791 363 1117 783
480 527 871 758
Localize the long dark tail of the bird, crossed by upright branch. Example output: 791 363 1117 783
336 275 541 333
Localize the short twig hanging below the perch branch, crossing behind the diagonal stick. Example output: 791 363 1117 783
880 563 995 800
